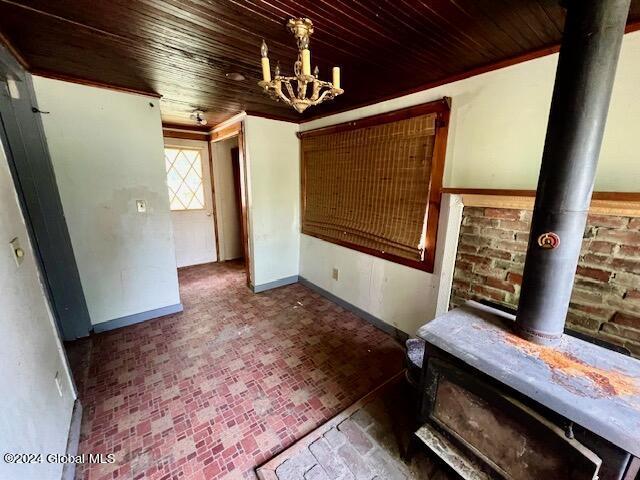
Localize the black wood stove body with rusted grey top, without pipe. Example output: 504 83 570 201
417 302 640 480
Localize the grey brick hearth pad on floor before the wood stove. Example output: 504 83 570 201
258 375 458 480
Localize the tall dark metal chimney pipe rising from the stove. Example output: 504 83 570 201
516 0 630 345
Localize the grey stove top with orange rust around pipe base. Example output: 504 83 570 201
418 302 640 456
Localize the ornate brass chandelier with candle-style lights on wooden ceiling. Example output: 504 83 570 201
258 18 344 113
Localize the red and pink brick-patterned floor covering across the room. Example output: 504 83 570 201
70 263 403 480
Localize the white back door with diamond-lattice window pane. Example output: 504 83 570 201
164 138 217 267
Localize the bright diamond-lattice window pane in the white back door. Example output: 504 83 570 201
164 148 204 210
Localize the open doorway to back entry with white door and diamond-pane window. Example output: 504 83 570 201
164 123 252 287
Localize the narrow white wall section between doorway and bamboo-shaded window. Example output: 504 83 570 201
245 116 300 286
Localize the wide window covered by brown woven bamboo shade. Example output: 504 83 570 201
300 100 449 271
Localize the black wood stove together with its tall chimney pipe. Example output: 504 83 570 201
416 0 640 480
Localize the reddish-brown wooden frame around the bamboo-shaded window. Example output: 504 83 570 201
298 97 451 273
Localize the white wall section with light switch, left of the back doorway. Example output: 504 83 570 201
33 77 180 325
